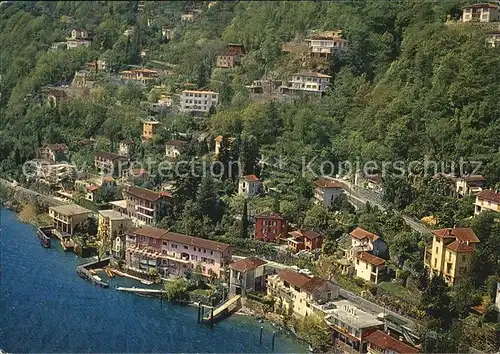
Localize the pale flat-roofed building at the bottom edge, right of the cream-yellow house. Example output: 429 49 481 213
323 300 384 353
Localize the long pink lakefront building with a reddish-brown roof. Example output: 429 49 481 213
125 226 233 278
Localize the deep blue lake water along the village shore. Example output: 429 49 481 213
0 210 306 353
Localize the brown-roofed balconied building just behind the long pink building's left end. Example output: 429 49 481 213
125 186 171 225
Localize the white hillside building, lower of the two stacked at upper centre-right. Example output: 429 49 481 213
280 72 331 96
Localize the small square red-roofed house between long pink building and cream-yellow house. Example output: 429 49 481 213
229 257 266 296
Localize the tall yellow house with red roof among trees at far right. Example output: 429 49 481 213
424 228 479 285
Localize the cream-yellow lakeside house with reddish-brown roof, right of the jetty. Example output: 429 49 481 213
267 270 340 316
